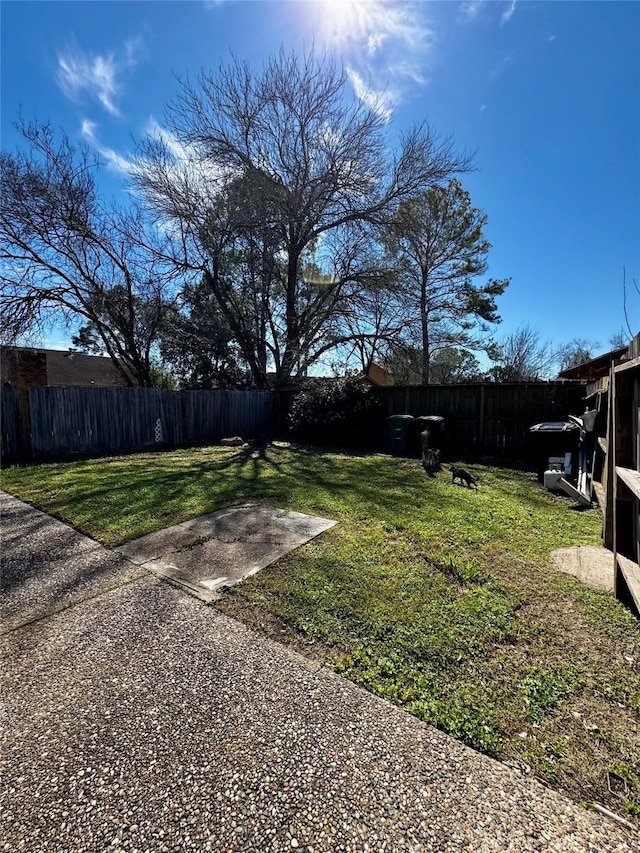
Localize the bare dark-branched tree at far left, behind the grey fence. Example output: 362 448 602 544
0 124 184 385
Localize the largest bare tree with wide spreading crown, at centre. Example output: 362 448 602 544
136 51 469 386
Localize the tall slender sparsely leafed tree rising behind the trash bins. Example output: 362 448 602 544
387 180 509 385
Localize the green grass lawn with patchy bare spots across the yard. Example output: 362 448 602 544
2 443 640 816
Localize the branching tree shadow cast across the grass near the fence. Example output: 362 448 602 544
2 445 596 545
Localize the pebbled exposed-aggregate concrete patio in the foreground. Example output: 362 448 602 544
0 490 640 853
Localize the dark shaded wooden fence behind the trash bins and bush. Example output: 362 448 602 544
274 382 585 458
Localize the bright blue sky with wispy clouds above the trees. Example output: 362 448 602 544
0 0 640 351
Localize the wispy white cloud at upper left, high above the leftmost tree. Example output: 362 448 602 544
57 40 141 116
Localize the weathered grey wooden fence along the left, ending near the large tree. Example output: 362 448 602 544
2 387 272 465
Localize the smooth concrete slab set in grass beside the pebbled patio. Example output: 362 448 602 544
116 506 336 601
